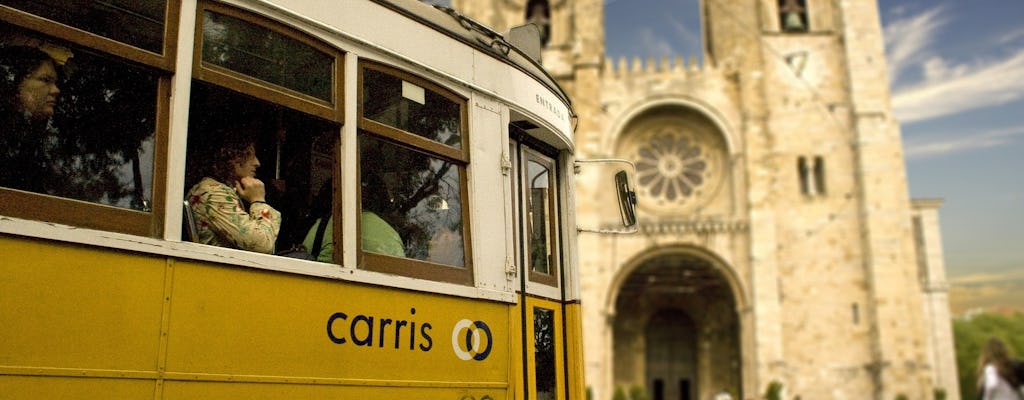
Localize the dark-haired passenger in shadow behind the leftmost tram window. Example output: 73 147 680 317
0 46 60 192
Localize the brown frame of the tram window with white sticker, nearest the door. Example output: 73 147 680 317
355 59 474 285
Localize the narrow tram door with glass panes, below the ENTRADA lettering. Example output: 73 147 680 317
509 128 566 400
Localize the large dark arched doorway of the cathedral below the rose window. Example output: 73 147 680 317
612 252 742 400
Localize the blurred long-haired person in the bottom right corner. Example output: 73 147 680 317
978 338 1021 400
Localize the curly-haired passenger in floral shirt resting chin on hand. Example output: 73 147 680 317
187 130 281 254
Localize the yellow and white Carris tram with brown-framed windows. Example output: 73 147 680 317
0 0 633 400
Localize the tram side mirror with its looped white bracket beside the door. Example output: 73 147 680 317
575 159 637 233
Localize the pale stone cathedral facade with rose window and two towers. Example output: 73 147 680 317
452 0 958 400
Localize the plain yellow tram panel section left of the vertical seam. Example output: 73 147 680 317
0 236 167 399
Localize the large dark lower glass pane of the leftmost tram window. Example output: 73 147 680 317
0 25 160 211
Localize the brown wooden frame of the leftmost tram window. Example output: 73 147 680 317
0 0 181 237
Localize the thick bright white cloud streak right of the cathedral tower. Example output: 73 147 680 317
893 49 1024 123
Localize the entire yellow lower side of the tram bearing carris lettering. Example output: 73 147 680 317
0 236 514 400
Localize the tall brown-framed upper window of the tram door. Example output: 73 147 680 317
524 149 558 285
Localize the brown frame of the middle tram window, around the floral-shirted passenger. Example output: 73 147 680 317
190 1 345 259
